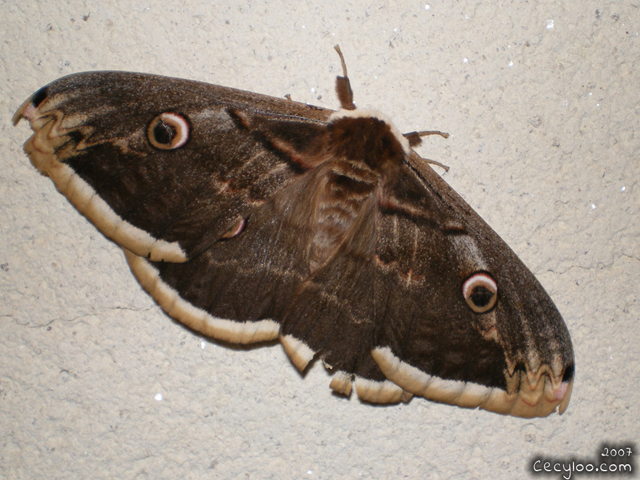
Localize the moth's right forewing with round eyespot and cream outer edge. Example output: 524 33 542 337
373 154 574 416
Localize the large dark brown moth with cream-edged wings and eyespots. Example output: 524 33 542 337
13 47 574 417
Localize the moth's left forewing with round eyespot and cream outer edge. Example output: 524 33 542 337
14 72 331 262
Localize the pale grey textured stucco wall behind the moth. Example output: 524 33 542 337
0 0 640 479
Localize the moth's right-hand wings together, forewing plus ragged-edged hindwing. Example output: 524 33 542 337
281 153 574 417
